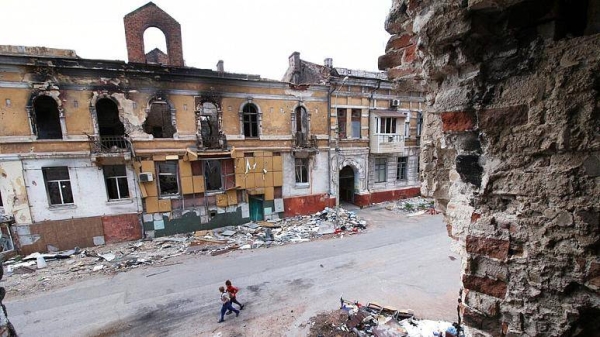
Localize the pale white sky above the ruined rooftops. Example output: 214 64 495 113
0 0 392 80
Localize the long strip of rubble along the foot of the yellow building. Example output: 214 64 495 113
3 208 367 296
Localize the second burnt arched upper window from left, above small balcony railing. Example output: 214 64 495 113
96 98 126 149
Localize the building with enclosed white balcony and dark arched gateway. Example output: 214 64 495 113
283 52 424 206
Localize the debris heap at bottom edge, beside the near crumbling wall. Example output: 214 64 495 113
309 298 463 337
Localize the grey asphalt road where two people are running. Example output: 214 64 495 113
5 208 460 337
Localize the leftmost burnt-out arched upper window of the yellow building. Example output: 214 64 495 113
33 96 62 139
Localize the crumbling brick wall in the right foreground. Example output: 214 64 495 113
380 0 600 336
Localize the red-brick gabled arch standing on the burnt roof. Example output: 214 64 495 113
123 2 183 67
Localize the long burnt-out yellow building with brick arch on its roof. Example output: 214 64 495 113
0 3 328 253
